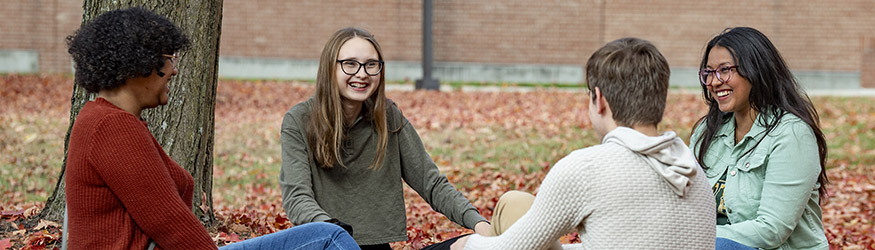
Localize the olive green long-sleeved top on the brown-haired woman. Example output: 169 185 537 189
279 98 486 245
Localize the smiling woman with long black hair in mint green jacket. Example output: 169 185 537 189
690 27 829 249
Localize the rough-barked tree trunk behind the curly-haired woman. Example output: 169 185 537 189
37 0 223 227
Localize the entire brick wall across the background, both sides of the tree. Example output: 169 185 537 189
0 0 875 76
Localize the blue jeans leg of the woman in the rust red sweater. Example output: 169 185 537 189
220 222 359 250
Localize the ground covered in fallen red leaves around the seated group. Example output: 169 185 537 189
0 75 875 250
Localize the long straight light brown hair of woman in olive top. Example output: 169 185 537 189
307 27 389 170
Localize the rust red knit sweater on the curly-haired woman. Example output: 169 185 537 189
64 98 216 249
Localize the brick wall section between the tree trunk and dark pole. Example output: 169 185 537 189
221 0 422 60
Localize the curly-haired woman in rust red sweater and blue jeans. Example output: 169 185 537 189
64 8 358 249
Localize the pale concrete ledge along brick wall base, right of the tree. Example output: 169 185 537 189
219 57 861 90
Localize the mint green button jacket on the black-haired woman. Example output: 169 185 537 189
690 113 829 249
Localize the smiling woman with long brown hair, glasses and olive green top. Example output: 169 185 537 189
279 28 489 249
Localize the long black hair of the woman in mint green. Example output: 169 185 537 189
690 27 829 200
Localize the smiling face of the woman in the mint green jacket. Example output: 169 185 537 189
705 46 751 113
